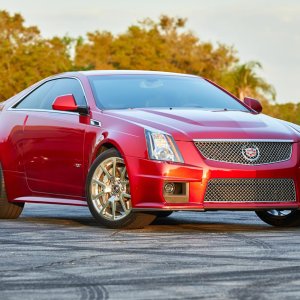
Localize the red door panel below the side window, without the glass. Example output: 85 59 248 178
21 111 86 197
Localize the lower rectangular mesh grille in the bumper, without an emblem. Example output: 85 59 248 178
204 178 296 202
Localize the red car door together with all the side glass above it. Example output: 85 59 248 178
15 78 87 197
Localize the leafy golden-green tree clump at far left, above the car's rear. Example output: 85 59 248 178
0 11 72 101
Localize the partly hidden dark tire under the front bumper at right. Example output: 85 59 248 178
255 209 300 227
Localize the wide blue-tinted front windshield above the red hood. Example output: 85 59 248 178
89 75 249 111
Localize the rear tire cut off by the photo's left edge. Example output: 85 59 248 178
0 166 24 219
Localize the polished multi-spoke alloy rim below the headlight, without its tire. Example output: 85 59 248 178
90 157 132 221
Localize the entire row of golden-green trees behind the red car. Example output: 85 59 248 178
0 11 300 123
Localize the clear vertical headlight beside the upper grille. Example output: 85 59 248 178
145 130 183 163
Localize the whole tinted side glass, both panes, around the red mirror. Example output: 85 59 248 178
15 78 86 110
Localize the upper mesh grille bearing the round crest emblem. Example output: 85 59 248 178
195 140 292 165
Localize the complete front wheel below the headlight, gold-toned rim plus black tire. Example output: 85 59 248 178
86 148 156 229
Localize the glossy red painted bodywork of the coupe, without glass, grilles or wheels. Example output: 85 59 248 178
0 71 300 210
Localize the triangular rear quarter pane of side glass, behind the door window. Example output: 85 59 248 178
14 80 55 109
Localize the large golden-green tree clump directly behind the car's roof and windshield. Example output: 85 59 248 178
75 15 238 81
